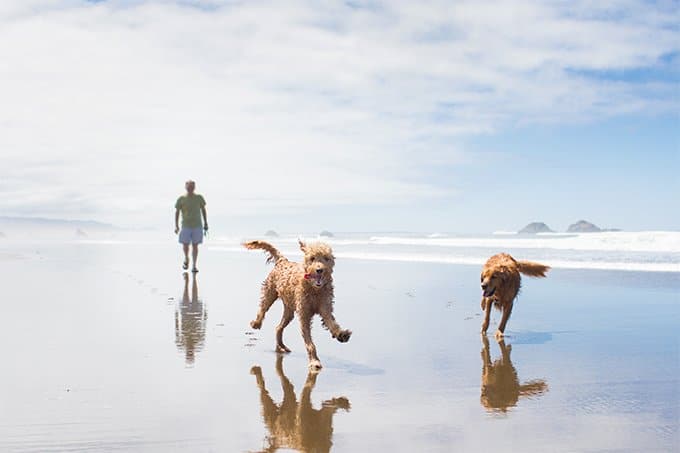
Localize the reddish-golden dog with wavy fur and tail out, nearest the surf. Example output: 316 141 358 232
481 253 550 339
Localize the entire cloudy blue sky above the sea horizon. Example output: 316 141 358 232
0 0 680 232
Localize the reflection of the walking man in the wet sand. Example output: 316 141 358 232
175 274 208 365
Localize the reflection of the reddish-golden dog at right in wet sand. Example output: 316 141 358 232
480 335 548 412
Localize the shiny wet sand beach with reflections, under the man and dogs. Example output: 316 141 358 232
0 243 680 452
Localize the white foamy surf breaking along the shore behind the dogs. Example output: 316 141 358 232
212 231 680 272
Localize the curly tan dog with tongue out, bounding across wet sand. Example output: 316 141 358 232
243 241 352 370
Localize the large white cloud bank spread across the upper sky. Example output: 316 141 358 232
0 0 679 226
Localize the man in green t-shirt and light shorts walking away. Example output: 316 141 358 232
175 180 208 272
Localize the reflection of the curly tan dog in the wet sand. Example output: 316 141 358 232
250 355 350 452
